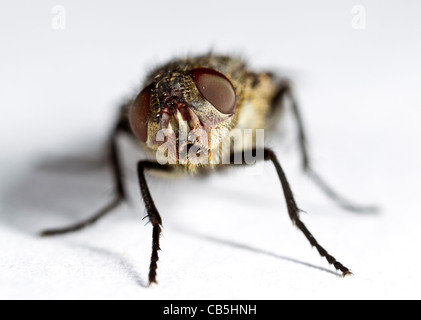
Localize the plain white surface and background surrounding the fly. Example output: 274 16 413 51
0 0 421 299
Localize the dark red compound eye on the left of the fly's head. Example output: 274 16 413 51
129 85 152 142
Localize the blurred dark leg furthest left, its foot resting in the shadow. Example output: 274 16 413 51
41 111 131 237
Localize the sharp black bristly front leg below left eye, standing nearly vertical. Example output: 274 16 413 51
137 161 172 285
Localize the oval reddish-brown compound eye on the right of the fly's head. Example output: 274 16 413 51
191 68 237 114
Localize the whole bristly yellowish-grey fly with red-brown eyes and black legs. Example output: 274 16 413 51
42 54 371 284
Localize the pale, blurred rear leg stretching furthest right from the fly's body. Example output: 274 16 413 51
272 81 377 213
